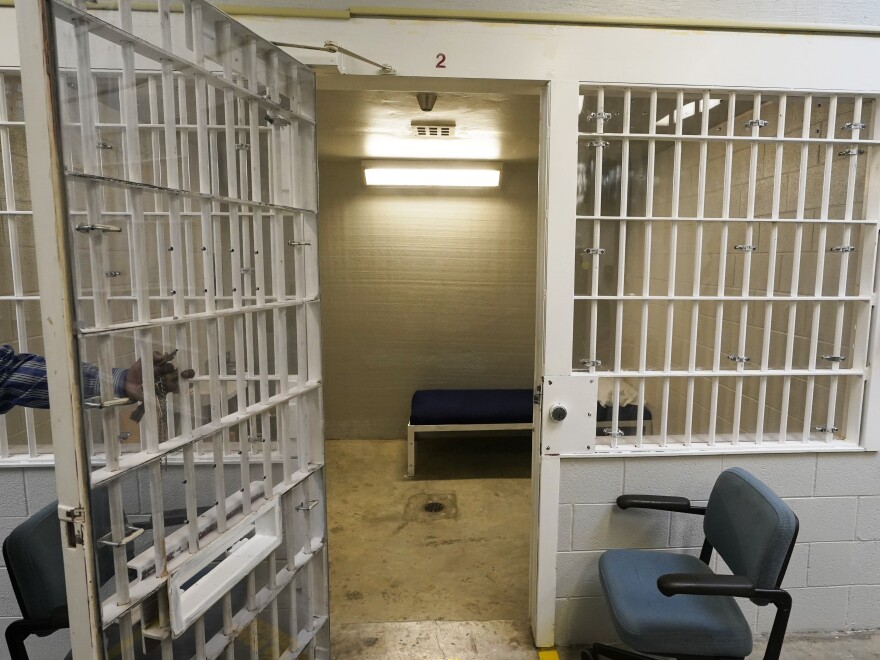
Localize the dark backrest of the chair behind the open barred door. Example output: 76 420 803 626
3 488 113 619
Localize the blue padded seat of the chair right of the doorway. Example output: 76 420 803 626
599 550 752 657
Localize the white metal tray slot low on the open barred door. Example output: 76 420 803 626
168 497 281 636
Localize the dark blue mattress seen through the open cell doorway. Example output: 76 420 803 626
409 390 533 426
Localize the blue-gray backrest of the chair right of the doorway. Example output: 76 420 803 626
703 468 798 589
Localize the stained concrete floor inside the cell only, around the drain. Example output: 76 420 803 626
326 439 531 628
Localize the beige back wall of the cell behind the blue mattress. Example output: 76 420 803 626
319 159 538 438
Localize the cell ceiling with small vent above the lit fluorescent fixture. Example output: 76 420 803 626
318 85 539 161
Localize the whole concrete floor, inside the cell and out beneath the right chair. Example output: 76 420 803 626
326 439 880 660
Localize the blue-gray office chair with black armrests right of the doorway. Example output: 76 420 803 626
581 468 798 660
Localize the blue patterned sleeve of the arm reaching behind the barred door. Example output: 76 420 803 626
0 344 128 414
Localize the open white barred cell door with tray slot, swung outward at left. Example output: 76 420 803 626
17 0 329 659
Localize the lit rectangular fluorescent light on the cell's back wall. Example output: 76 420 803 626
363 160 501 188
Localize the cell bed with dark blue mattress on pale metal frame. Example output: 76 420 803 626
406 389 651 477
